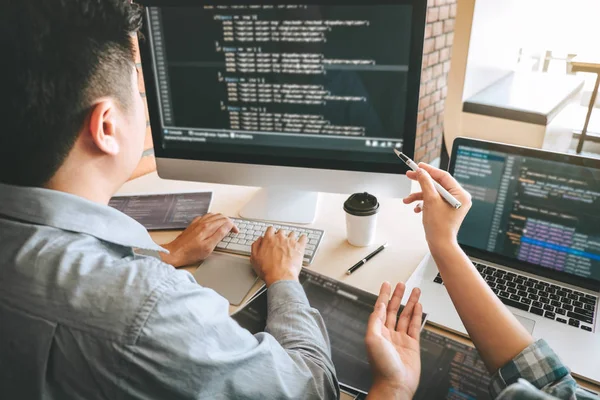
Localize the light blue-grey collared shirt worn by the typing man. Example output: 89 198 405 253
0 184 339 399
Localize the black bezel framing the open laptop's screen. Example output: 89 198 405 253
448 137 600 291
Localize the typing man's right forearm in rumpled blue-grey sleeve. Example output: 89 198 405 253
265 281 339 398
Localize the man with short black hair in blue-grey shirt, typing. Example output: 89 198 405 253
0 0 339 399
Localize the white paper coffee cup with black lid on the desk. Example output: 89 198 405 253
344 192 379 247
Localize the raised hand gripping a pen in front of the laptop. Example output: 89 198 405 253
404 163 471 251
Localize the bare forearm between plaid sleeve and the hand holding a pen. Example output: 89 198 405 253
431 241 533 373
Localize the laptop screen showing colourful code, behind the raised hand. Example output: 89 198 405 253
450 139 600 281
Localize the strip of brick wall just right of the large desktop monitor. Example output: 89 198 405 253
415 0 456 162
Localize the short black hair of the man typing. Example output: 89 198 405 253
0 0 142 187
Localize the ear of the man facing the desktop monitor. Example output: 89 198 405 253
89 99 120 156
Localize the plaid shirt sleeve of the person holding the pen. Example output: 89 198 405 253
490 340 600 400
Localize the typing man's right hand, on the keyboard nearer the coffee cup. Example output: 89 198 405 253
250 227 308 287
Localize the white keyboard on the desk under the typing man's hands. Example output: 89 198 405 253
215 218 325 265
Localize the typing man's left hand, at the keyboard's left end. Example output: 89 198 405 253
161 213 239 268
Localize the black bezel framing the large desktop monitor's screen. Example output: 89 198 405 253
136 0 427 174
